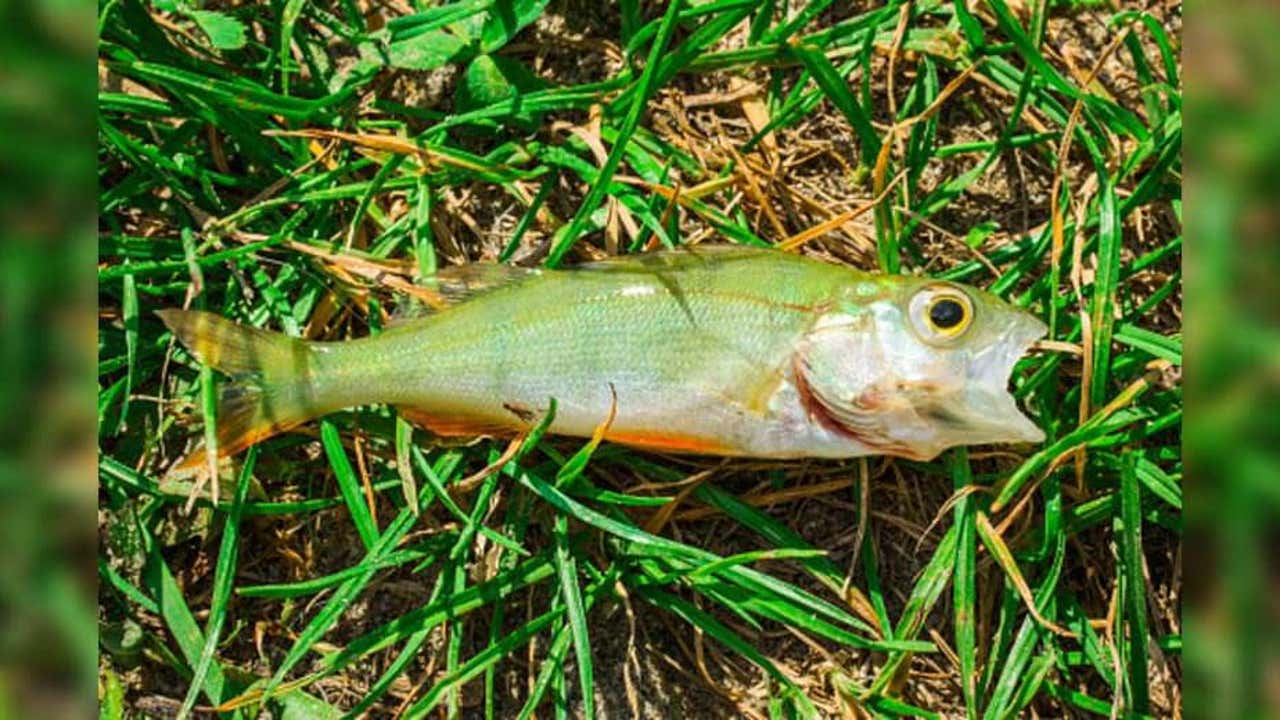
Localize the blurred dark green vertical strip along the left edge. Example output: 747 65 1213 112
0 0 97 719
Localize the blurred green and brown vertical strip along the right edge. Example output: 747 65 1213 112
1183 0 1280 717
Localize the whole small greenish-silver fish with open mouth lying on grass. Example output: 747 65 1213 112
157 245 1046 473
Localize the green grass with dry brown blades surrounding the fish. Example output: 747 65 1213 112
97 0 1183 719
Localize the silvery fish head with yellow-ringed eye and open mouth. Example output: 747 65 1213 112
796 277 1047 460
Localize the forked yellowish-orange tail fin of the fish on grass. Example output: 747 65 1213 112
156 310 325 474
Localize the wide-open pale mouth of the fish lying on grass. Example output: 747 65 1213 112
948 314 1048 445
